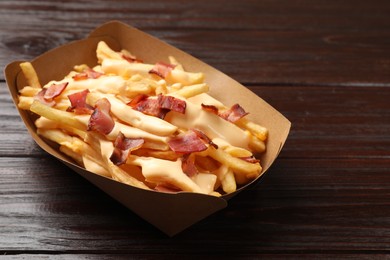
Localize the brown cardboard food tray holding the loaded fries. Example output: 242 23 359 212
5 21 291 236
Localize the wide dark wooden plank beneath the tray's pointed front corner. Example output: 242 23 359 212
0 158 390 255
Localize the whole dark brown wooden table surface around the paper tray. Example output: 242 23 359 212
0 0 390 259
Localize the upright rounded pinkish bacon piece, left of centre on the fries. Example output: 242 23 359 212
87 98 115 135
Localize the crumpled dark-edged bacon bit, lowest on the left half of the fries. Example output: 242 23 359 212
110 132 145 165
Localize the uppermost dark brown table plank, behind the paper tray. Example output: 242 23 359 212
0 0 390 86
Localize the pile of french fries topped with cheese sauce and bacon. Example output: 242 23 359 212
18 42 268 196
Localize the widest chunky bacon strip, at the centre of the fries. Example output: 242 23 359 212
128 94 186 119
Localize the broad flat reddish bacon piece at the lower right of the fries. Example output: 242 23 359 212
168 130 207 154
